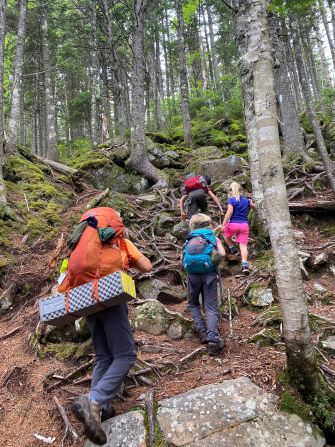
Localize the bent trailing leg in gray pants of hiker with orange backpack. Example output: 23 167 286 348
90 305 136 408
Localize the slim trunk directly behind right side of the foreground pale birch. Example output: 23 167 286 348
269 15 305 154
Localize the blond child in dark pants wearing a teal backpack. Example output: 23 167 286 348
182 214 226 356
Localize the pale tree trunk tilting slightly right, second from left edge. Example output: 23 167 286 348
6 0 27 154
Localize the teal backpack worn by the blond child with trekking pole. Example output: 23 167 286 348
183 228 218 273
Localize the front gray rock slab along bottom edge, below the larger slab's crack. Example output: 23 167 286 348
192 414 325 447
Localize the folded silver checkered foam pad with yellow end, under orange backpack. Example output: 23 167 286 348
39 272 136 326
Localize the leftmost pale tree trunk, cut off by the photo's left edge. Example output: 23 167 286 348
0 0 7 208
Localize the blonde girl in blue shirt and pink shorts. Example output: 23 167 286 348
222 182 255 274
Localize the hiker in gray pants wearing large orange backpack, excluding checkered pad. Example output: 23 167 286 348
58 207 152 445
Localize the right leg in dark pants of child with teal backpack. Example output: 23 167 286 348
203 272 220 343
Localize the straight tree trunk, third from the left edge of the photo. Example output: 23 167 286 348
39 0 58 161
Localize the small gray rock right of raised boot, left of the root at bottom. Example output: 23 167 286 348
85 411 146 447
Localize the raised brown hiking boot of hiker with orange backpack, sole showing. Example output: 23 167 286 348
72 395 107 445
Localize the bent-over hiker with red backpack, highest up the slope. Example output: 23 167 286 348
179 172 223 220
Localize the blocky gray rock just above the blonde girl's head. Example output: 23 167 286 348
200 155 243 182
